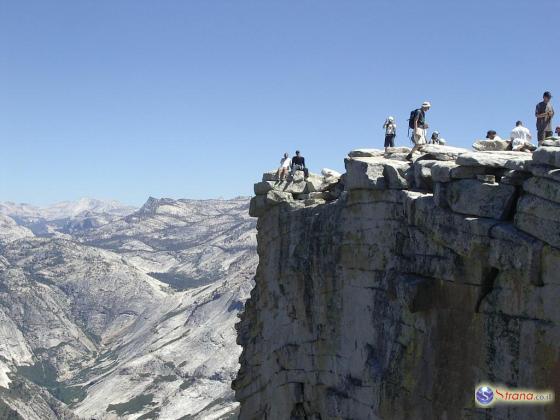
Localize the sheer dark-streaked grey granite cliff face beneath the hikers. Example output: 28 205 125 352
233 145 560 420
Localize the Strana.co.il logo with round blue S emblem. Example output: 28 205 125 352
474 384 554 408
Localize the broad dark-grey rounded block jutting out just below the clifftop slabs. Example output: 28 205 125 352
442 179 516 220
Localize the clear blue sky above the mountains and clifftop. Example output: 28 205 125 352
0 0 560 205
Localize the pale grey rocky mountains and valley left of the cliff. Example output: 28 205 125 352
0 198 257 420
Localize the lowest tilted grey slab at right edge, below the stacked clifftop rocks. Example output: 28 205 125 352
515 194 560 248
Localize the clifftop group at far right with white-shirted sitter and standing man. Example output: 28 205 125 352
486 91 560 153
